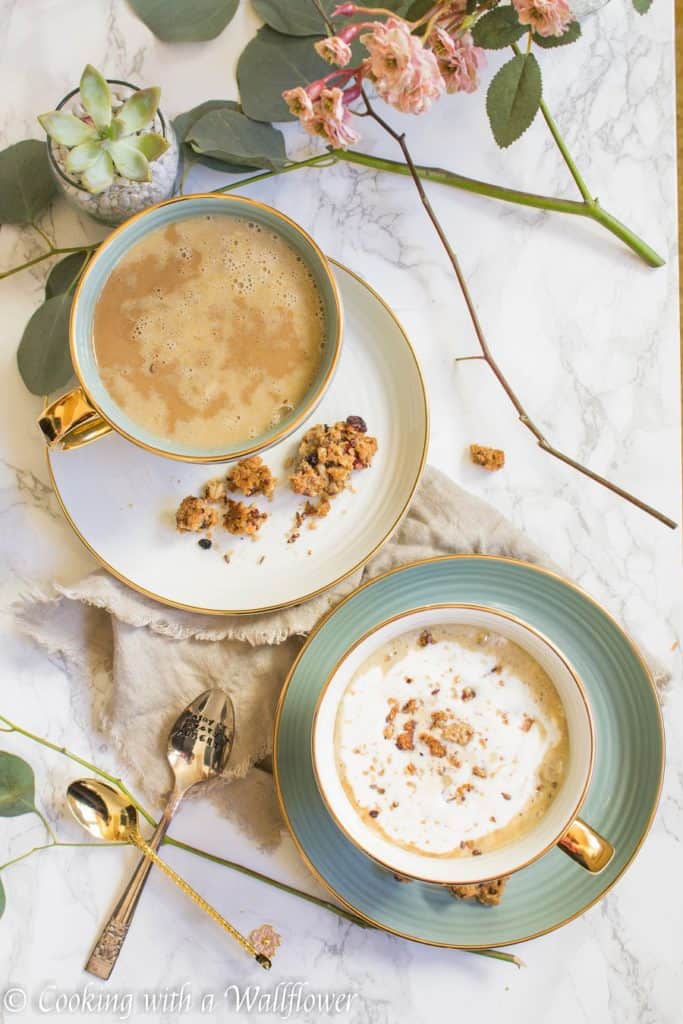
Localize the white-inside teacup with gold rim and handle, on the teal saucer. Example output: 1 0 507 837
311 604 614 885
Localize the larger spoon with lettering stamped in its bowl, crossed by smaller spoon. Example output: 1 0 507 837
85 688 234 981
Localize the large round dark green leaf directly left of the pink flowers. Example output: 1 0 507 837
238 26 330 121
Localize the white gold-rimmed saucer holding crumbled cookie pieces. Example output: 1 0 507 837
48 264 429 614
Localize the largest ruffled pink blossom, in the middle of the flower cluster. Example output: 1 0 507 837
360 17 443 114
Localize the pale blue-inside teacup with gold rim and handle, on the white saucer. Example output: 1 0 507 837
38 193 343 463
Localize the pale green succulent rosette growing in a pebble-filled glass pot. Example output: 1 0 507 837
38 65 168 193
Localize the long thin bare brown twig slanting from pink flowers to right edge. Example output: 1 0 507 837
352 90 677 529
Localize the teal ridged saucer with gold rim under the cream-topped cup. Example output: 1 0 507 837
273 555 664 947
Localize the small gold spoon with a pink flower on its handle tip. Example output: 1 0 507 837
67 778 271 971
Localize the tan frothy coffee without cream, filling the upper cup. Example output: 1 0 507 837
94 215 325 449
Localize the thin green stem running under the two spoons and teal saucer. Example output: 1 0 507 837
0 715 523 967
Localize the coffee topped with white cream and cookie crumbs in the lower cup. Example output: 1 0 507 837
335 626 568 856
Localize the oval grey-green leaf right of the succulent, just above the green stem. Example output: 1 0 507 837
187 109 287 171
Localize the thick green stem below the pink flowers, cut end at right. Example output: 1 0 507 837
335 150 665 267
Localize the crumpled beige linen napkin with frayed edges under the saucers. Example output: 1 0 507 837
15 467 666 847
